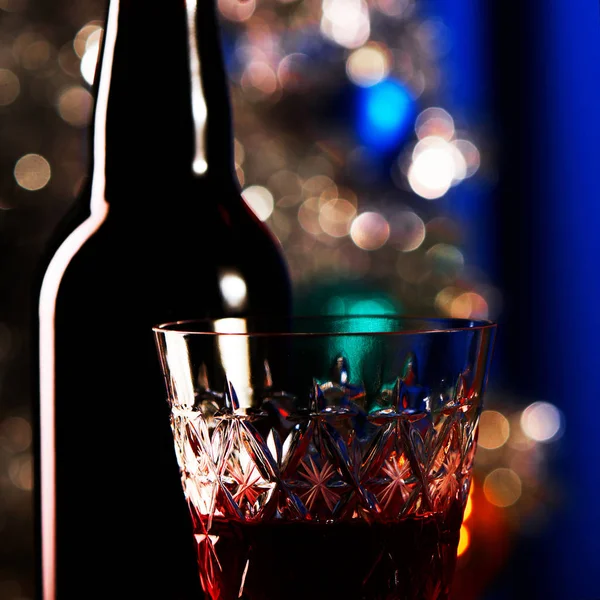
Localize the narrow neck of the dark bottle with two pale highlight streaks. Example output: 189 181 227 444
92 0 233 204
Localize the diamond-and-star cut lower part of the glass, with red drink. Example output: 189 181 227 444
163 346 488 600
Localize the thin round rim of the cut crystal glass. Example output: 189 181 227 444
152 313 498 337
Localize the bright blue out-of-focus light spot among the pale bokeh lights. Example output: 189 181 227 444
357 79 415 151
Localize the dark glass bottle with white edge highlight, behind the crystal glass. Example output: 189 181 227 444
34 0 291 600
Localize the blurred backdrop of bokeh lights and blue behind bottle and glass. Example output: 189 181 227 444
0 0 600 600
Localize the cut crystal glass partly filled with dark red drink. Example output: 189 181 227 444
154 315 496 600
